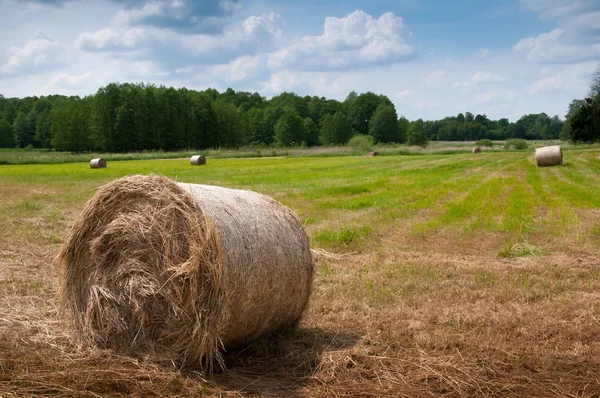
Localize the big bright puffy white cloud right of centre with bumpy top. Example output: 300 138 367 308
268 10 415 70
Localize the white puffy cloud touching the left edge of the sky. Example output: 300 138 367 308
0 31 68 75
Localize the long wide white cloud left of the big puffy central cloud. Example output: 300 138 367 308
76 13 281 67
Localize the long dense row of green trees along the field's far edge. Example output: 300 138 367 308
0 83 578 152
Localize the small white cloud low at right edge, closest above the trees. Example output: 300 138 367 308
529 61 598 94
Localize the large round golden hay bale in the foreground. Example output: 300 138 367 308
58 175 313 367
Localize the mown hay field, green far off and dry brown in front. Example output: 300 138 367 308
0 149 600 397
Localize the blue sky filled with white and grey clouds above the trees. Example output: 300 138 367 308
0 0 600 121
